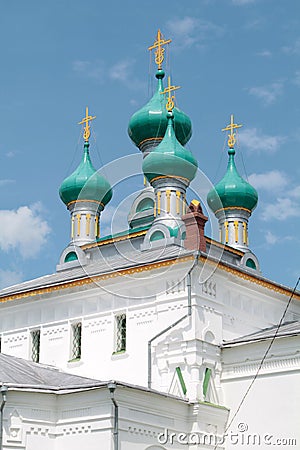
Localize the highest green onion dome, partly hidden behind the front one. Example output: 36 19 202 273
128 69 192 152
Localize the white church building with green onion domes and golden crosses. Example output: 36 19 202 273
0 31 300 450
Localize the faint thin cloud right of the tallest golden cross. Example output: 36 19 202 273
167 16 224 49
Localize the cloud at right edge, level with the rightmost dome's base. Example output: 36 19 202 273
261 197 300 221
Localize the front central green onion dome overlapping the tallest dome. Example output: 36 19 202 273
143 113 198 183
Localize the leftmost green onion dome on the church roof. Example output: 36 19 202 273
59 142 112 207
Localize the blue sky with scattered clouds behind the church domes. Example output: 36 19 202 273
0 0 300 286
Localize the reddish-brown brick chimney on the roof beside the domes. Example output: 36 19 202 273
182 200 208 252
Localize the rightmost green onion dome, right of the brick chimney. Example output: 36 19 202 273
207 148 258 213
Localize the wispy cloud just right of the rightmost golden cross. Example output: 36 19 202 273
238 128 286 154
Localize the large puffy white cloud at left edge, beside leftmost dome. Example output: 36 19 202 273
0 203 51 259
